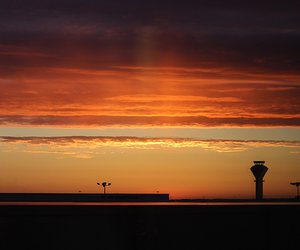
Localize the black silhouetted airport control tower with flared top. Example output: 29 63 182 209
250 161 268 200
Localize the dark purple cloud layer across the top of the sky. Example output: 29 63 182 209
0 0 300 71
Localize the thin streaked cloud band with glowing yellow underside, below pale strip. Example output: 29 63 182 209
0 136 300 159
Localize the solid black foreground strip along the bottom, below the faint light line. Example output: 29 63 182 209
0 205 300 250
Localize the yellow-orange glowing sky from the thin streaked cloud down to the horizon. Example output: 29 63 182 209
0 137 300 198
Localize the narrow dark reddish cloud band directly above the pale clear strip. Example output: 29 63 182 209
0 116 300 127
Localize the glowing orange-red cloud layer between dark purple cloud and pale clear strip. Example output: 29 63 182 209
0 67 300 127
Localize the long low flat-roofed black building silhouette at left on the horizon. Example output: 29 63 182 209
0 193 169 202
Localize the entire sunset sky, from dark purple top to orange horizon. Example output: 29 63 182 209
0 0 300 198
